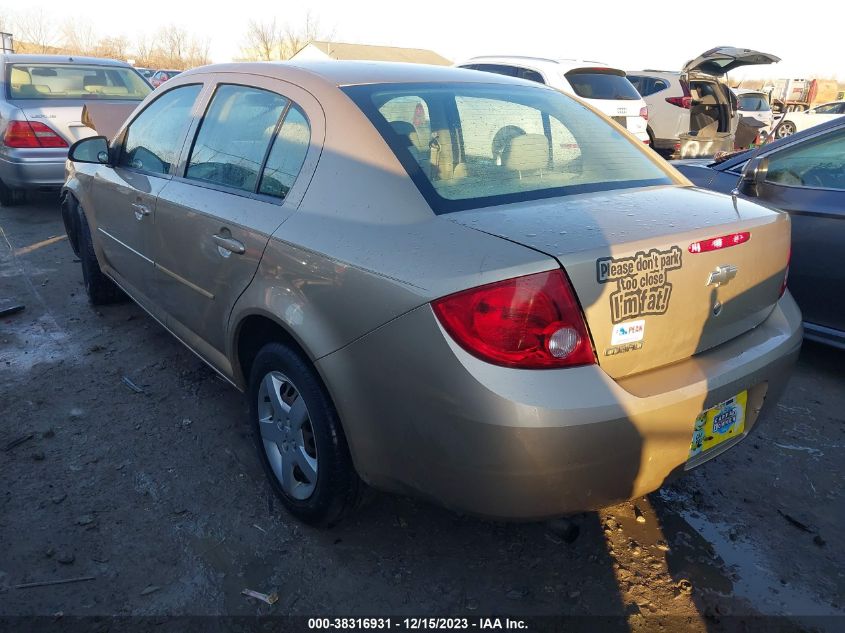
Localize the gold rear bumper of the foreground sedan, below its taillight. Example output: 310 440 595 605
317 293 802 519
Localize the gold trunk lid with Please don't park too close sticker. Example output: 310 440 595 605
450 186 790 378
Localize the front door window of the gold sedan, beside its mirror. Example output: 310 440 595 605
118 84 202 174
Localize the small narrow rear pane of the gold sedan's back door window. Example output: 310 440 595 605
258 105 311 199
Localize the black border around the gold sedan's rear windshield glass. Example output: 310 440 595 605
341 83 676 215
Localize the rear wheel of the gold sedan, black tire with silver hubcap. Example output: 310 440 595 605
248 343 364 527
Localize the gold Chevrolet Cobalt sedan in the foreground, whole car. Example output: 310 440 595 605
65 61 801 524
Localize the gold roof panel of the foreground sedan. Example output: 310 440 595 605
179 60 543 90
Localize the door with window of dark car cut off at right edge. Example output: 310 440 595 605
744 127 845 330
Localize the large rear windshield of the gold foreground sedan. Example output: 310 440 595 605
344 84 672 213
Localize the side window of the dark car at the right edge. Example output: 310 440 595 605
766 131 845 191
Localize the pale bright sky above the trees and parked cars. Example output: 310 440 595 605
0 0 845 79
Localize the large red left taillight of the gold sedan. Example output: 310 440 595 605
431 270 595 369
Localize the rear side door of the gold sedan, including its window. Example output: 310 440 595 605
155 74 324 369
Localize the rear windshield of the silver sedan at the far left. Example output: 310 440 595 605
6 64 152 101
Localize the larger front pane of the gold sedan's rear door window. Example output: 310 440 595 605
185 85 288 192
